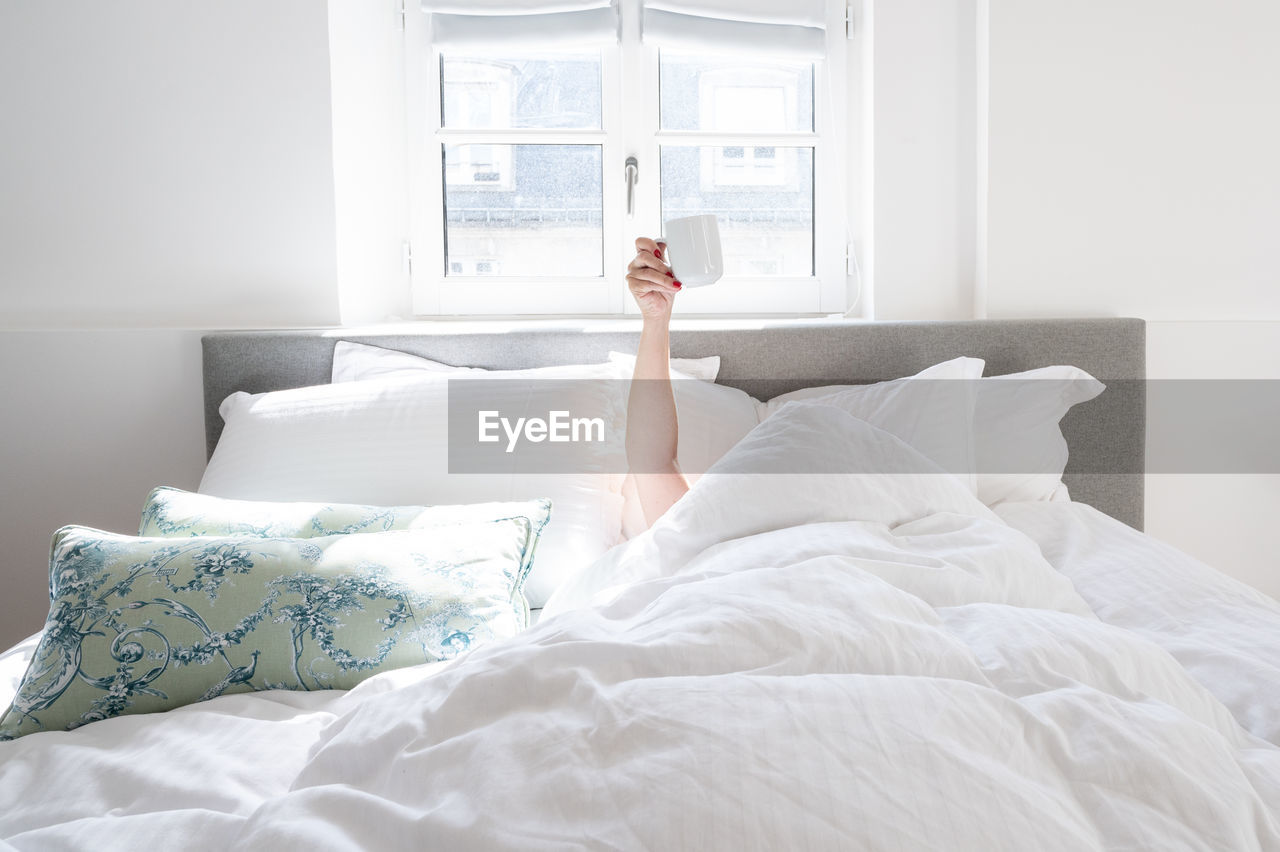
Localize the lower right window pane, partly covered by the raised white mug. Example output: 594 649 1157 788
662 145 814 276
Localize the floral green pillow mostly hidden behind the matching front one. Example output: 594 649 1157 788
138 486 552 593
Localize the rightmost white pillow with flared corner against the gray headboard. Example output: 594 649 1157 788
974 366 1106 505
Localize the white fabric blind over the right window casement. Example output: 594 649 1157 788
644 0 826 59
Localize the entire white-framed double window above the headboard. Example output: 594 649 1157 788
406 0 847 315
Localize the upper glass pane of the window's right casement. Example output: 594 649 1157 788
658 50 813 133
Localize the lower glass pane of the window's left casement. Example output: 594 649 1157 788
444 145 604 276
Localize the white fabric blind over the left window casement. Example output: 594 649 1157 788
422 0 618 49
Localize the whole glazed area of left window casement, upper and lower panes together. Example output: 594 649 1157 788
438 50 604 280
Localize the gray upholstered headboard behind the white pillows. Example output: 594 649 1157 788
204 319 1146 530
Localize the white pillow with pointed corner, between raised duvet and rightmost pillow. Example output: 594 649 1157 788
759 357 986 494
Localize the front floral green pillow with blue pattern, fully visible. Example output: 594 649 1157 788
0 517 538 739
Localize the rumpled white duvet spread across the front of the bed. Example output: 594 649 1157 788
0 404 1280 849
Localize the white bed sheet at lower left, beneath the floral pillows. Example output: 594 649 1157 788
0 636 448 849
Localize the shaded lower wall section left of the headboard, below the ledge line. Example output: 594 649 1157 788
0 329 205 647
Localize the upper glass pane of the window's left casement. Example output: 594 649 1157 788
440 51 600 130
